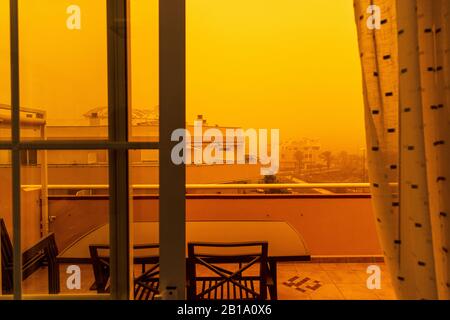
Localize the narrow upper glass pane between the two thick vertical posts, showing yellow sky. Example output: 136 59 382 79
130 0 159 141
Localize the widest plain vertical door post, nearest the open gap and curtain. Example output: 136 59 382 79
159 0 186 299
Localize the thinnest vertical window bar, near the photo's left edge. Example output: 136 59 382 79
10 0 22 299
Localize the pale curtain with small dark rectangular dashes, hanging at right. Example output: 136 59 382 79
354 0 450 299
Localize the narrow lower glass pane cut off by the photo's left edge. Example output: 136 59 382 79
0 150 13 295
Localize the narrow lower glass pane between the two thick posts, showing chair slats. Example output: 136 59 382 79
129 150 159 300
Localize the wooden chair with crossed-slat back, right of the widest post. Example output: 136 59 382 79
187 242 270 300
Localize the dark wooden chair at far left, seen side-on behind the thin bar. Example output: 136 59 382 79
0 219 60 294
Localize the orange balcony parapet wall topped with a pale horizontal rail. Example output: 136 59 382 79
16 183 384 257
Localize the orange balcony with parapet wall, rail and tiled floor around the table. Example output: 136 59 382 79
0 183 395 299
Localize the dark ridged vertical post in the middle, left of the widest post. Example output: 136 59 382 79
107 0 130 300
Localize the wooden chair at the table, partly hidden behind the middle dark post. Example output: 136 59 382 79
89 244 159 300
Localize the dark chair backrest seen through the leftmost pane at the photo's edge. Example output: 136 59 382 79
0 218 13 294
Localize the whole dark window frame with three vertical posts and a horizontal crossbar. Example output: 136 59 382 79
0 0 186 300
